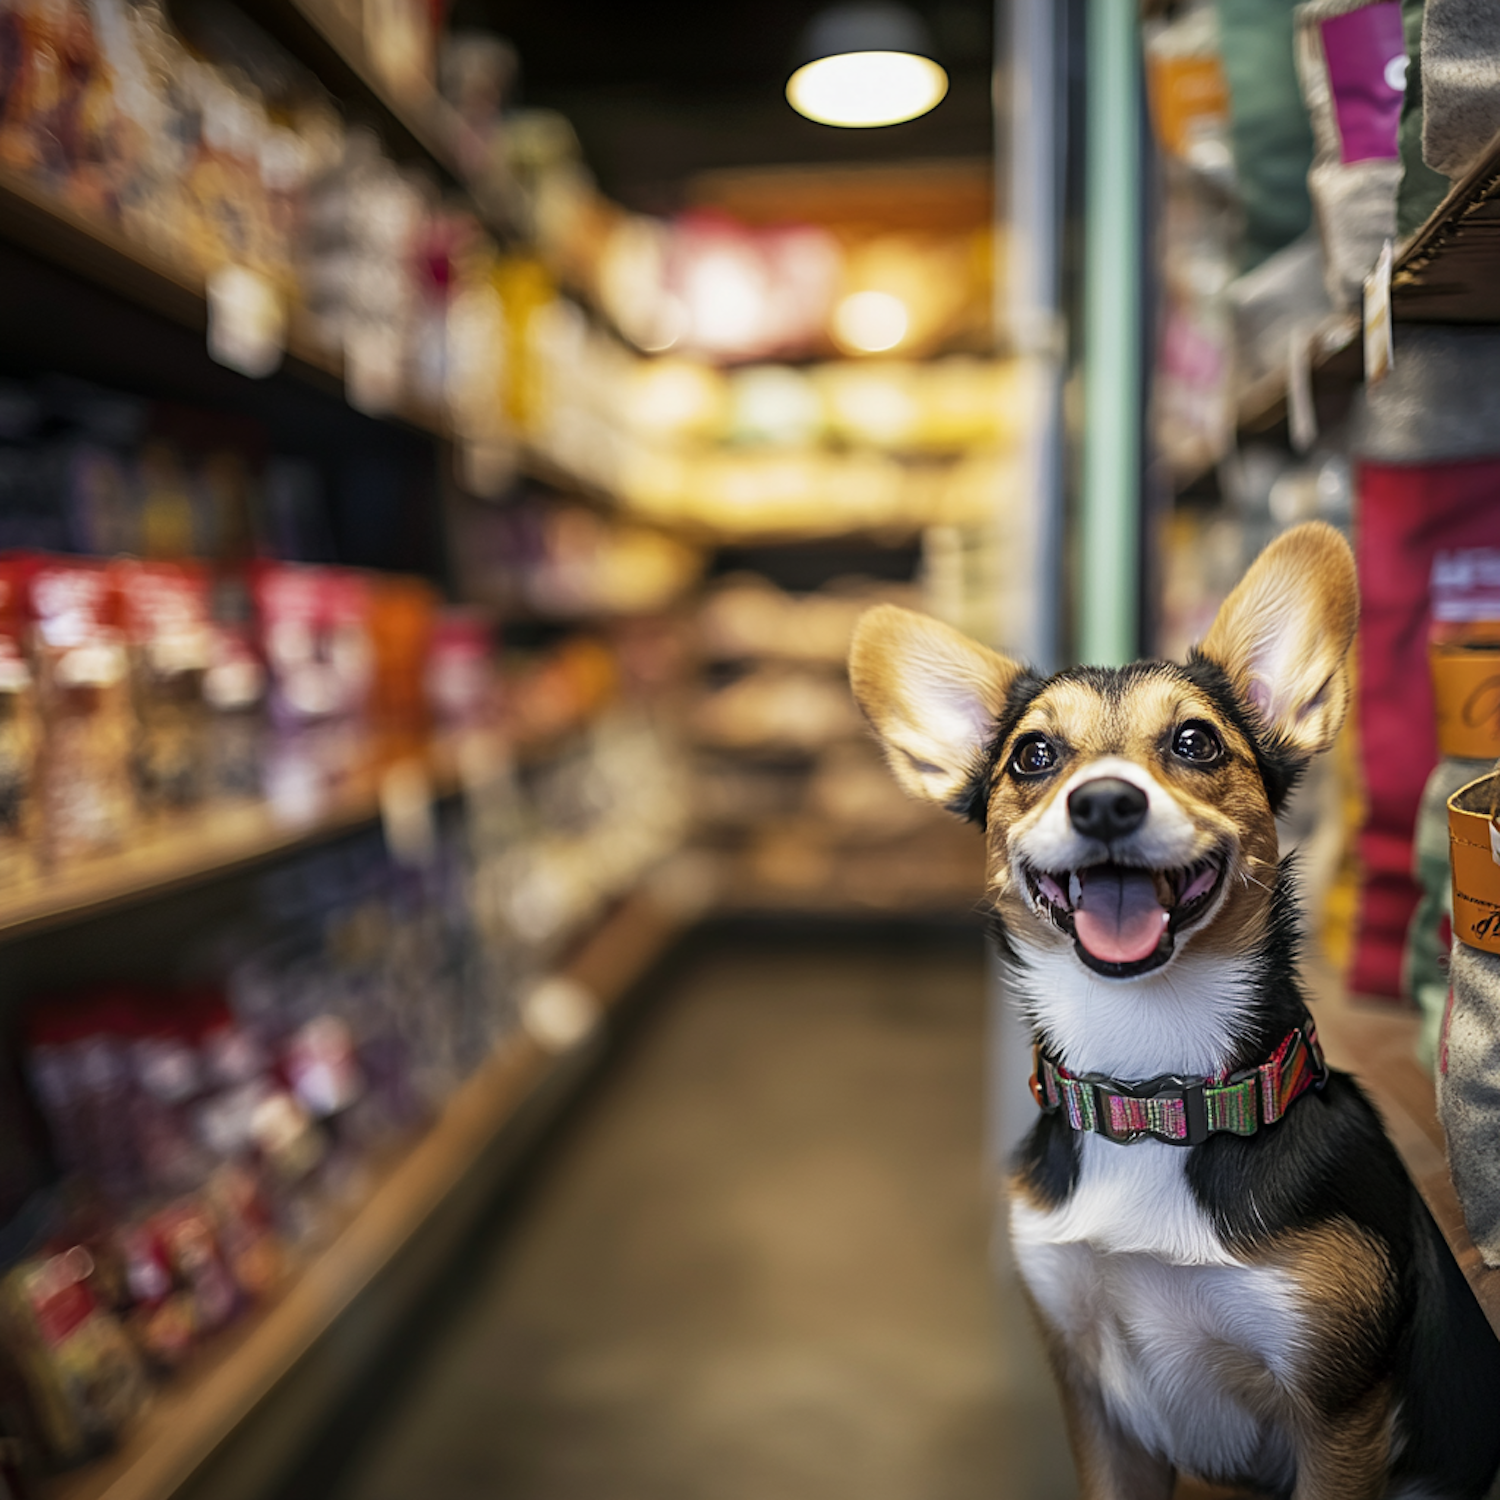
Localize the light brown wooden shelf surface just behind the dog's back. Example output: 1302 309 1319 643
1311 971 1500 1335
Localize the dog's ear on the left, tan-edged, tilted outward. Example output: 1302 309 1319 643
849 605 1023 812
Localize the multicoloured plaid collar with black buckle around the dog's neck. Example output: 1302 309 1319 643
1031 1017 1328 1146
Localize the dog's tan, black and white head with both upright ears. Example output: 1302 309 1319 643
849 524 1359 980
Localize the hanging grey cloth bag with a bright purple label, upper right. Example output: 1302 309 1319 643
1296 0 1407 309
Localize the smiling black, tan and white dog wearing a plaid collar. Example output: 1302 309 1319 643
851 522 1500 1500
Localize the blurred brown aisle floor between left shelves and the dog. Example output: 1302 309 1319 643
316 935 1073 1500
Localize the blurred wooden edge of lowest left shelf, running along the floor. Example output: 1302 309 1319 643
44 893 681 1500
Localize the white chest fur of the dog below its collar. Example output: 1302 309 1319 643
1011 1136 1299 1484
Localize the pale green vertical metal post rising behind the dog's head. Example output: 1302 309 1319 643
1077 0 1143 665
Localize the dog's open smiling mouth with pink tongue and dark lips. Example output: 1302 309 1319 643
1026 855 1224 980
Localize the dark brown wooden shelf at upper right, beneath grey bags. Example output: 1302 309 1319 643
1391 135 1500 323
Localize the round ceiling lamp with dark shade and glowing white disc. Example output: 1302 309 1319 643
786 0 948 129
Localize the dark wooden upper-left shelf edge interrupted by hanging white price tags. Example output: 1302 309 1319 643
0 167 447 437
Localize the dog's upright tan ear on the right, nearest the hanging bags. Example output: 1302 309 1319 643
1200 521 1359 756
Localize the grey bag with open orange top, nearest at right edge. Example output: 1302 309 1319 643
1437 773 1500 1266
